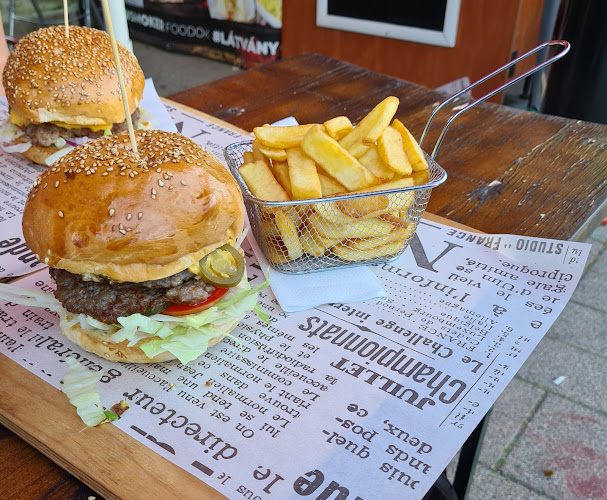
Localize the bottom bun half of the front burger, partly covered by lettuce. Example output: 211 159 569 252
61 313 230 363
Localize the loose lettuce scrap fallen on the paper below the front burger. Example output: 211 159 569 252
61 358 106 427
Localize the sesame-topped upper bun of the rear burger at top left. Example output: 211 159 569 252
2 25 145 126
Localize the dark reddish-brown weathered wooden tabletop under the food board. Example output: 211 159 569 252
0 55 607 500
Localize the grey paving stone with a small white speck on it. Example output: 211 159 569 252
518 337 607 414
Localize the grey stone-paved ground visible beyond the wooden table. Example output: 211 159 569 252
134 42 607 500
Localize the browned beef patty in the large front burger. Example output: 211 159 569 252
49 268 215 324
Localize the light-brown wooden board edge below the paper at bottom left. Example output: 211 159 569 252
0 354 225 500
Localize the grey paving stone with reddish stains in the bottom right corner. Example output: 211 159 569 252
498 395 607 500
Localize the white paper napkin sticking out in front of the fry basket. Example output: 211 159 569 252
247 233 386 312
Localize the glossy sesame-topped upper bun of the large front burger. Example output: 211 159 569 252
23 130 244 282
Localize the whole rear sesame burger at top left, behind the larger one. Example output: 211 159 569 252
1 25 145 166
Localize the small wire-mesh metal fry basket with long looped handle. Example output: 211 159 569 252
224 40 569 274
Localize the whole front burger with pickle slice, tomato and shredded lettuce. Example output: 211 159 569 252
3 131 264 363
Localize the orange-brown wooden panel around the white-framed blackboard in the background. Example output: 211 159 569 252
282 0 543 101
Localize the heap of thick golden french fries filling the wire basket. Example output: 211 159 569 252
239 96 430 265
